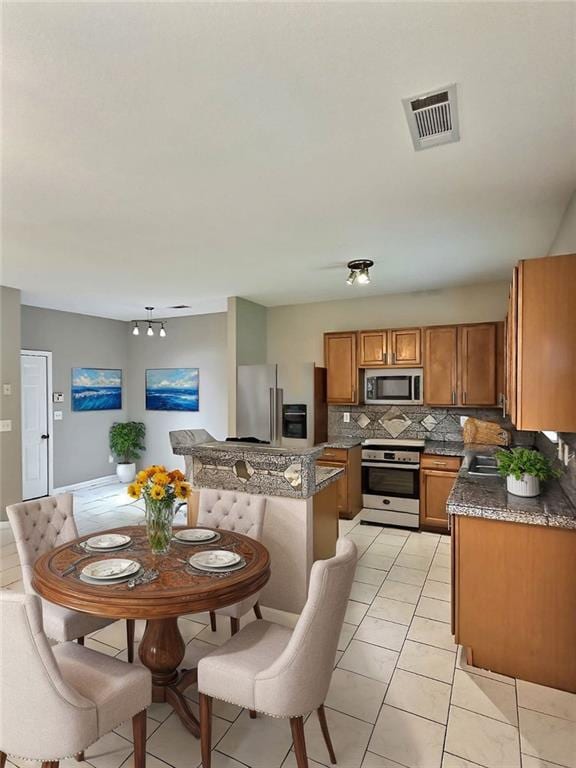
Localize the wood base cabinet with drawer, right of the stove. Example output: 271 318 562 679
420 454 460 533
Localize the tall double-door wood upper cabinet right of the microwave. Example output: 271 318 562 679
424 323 504 406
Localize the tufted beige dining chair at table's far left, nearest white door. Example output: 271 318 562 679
6 493 134 662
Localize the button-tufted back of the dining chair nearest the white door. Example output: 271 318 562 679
6 493 78 592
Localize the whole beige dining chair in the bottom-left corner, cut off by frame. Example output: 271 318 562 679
0 591 152 768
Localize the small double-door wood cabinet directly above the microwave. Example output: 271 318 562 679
358 328 422 368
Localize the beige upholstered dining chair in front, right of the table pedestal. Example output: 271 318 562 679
198 539 357 768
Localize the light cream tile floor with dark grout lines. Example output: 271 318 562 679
0 484 576 768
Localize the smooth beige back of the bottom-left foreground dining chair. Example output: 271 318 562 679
0 590 98 760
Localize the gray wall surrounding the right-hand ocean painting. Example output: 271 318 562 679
125 313 228 467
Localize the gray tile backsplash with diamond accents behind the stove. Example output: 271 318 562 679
328 405 535 445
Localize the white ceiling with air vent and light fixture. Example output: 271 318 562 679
1 2 576 319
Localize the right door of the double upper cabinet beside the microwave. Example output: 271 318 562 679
459 323 498 406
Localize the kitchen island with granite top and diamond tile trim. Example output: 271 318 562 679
174 441 343 613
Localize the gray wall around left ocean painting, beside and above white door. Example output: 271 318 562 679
22 306 129 487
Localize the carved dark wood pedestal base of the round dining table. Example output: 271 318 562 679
138 618 200 738
